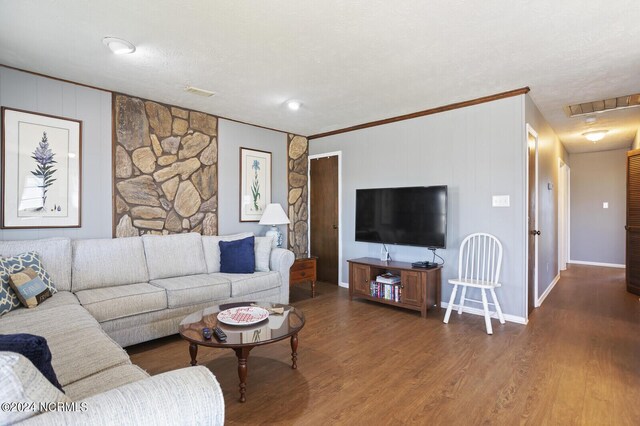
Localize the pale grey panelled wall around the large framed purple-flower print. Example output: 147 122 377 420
0 67 112 240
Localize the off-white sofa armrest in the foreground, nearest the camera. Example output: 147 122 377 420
21 367 224 426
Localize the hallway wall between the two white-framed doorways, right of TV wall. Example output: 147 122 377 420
525 95 573 297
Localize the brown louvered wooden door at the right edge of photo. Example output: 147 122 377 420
625 149 640 295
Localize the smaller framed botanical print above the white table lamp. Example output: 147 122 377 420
240 147 271 222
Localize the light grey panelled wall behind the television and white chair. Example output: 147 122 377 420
310 96 526 318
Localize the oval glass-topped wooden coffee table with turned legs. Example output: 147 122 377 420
179 302 304 402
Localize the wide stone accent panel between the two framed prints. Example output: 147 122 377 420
113 95 218 237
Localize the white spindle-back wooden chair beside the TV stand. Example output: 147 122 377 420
444 232 504 334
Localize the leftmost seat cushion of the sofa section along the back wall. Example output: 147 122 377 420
76 283 167 322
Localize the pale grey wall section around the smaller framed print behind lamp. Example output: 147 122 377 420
218 119 288 236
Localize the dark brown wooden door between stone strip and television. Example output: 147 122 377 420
310 155 338 284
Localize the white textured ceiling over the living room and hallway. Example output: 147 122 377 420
0 0 640 152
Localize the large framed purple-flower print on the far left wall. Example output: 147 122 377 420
0 107 82 229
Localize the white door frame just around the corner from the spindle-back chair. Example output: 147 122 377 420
524 123 540 314
